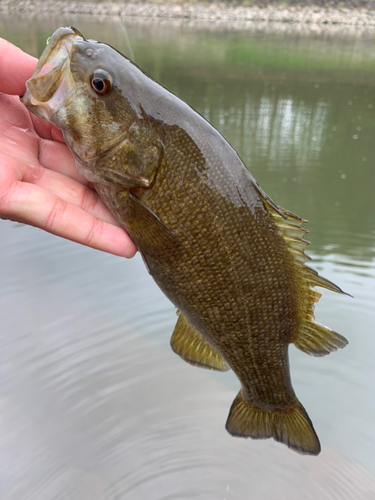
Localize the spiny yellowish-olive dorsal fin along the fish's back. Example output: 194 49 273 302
265 200 348 356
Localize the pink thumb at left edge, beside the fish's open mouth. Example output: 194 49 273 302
0 38 37 96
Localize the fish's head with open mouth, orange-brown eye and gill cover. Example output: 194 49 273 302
23 28 164 188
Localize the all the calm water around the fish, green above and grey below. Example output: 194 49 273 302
0 16 375 500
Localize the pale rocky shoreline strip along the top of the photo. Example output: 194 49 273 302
0 0 375 27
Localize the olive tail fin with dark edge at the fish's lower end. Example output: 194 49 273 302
226 391 320 455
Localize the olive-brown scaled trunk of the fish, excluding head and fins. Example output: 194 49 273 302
99 124 298 407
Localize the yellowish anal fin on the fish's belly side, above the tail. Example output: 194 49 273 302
171 312 229 372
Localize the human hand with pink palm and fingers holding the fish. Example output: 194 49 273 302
0 38 136 257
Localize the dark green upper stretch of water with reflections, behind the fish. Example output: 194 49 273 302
0 13 375 260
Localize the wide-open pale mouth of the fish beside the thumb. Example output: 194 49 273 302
22 27 84 123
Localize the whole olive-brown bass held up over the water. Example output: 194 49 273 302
23 27 348 455
